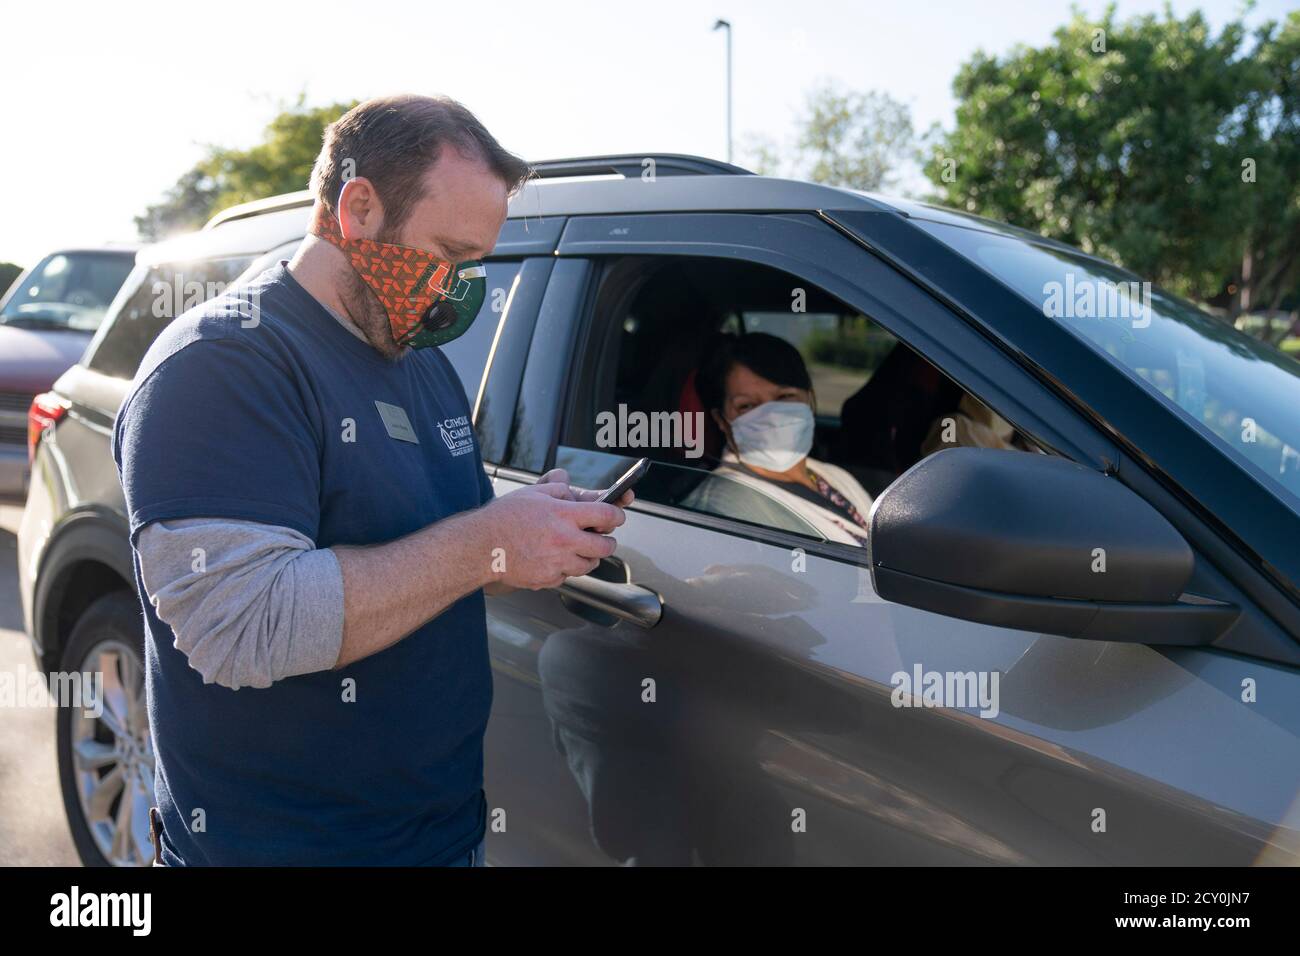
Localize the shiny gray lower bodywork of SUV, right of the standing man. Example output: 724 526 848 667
489 468 1300 865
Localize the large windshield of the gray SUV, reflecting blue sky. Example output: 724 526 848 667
918 221 1300 512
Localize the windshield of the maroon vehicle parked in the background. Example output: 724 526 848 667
0 252 134 332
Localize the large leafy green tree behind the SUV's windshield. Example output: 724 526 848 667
926 5 1300 332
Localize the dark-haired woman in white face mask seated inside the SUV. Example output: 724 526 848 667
684 332 871 546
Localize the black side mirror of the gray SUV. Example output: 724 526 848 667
868 447 1238 644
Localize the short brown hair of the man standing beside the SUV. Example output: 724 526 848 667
311 94 532 233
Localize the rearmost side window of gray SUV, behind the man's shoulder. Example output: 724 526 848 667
87 256 251 378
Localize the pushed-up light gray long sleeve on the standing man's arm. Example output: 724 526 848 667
137 518 343 689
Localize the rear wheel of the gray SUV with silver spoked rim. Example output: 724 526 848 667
57 592 153 866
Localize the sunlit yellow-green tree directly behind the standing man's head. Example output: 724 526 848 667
135 98 356 241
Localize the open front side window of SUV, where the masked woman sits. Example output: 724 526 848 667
555 258 1023 545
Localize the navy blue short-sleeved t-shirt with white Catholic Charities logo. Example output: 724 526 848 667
113 263 493 865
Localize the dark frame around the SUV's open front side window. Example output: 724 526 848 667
497 212 1115 564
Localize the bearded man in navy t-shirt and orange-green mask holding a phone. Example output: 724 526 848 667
113 96 631 865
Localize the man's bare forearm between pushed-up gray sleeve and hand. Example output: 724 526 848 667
332 509 497 669
